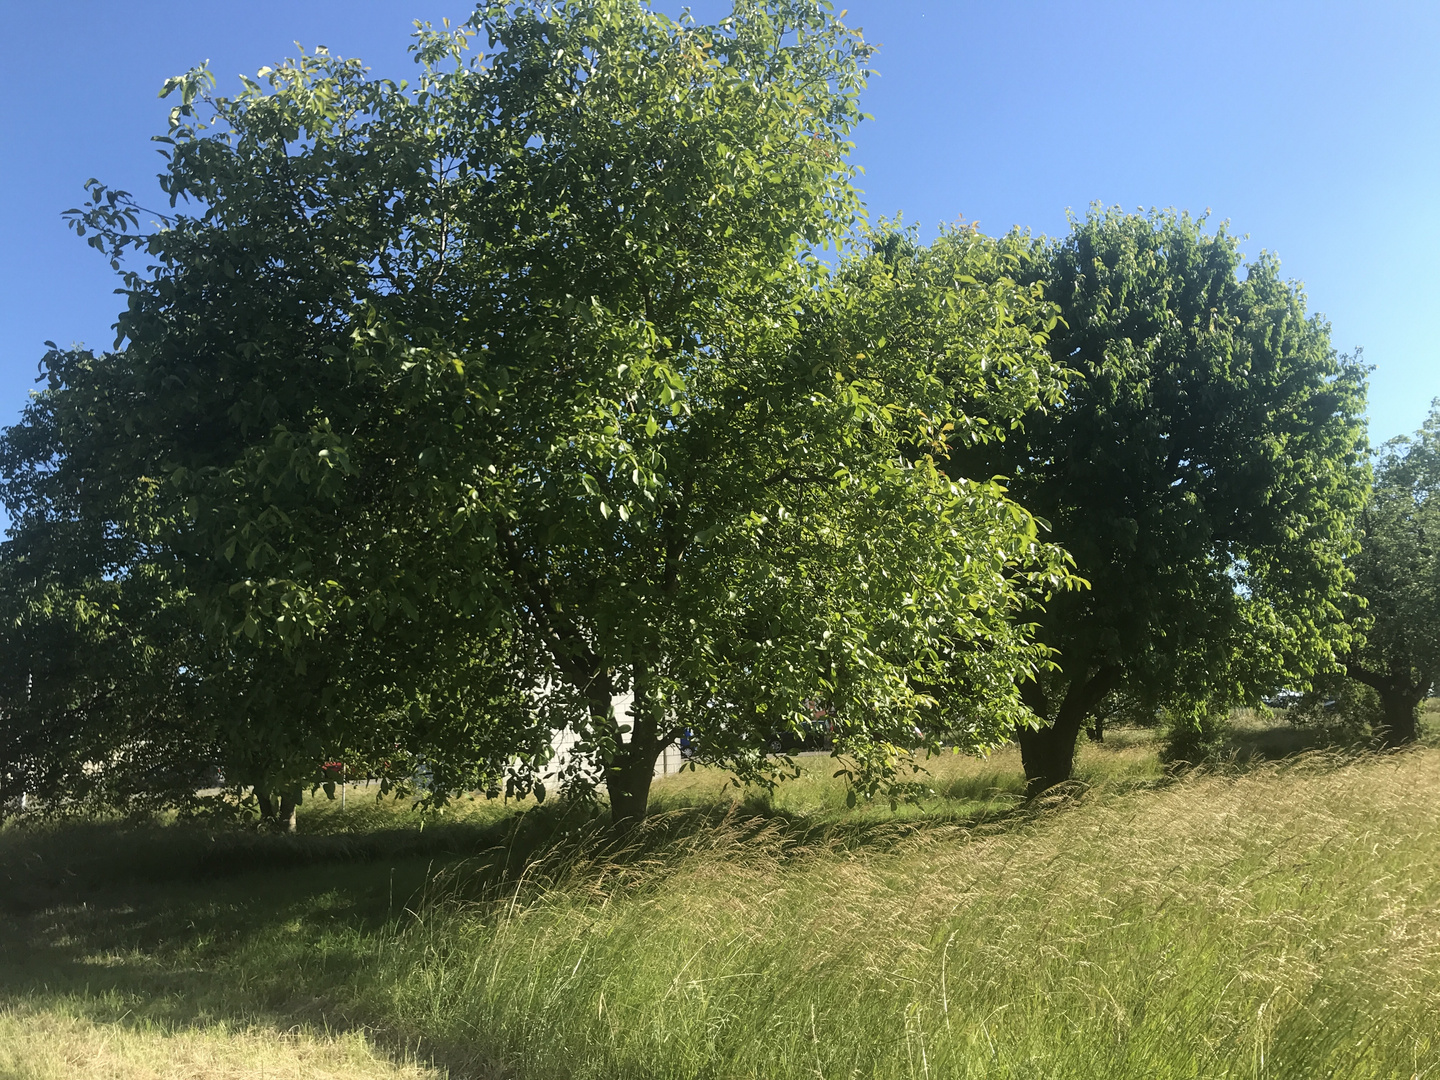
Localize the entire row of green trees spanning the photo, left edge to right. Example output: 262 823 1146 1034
0 0 1440 825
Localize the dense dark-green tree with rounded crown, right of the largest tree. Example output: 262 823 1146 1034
956 210 1367 791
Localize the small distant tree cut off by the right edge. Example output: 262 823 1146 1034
1345 400 1440 746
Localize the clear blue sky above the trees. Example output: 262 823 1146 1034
0 0 1440 466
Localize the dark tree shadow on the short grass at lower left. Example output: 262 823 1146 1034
0 811 630 1076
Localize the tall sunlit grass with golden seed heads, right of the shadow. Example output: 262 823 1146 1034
348 753 1440 1077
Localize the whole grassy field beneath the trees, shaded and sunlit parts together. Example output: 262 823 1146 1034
0 714 1440 1080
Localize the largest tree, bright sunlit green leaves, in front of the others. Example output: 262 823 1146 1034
5 0 1067 821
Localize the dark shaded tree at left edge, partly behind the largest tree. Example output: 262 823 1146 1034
0 334 541 811
